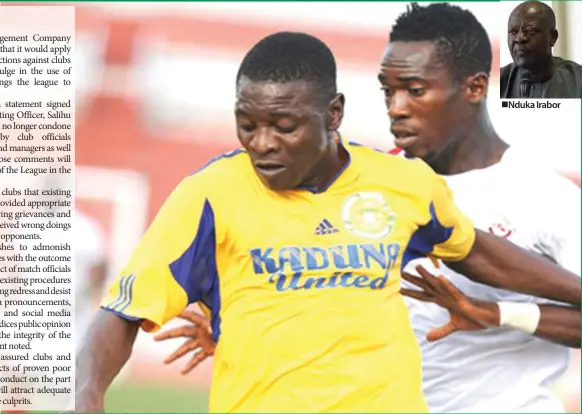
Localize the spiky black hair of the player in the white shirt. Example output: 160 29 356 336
390 3 493 81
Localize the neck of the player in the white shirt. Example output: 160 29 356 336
431 114 509 175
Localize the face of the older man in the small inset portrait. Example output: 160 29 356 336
507 5 558 68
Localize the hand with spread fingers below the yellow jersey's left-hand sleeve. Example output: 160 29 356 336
154 311 216 375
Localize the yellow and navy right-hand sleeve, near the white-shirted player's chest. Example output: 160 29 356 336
402 160 475 269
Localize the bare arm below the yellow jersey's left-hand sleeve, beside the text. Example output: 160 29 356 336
75 310 139 412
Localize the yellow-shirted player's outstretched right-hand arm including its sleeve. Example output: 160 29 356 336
410 165 580 307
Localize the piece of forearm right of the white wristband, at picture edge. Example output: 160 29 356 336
534 305 580 348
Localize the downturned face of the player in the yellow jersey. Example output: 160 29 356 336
235 77 343 191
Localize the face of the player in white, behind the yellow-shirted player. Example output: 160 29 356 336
378 42 482 163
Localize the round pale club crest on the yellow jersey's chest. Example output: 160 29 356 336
341 192 396 240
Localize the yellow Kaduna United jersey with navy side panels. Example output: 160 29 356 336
103 137 475 413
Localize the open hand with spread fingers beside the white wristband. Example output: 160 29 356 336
400 265 499 341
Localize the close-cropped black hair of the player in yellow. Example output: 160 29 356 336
236 32 337 99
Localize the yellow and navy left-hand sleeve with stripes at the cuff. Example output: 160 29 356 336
101 176 218 331
